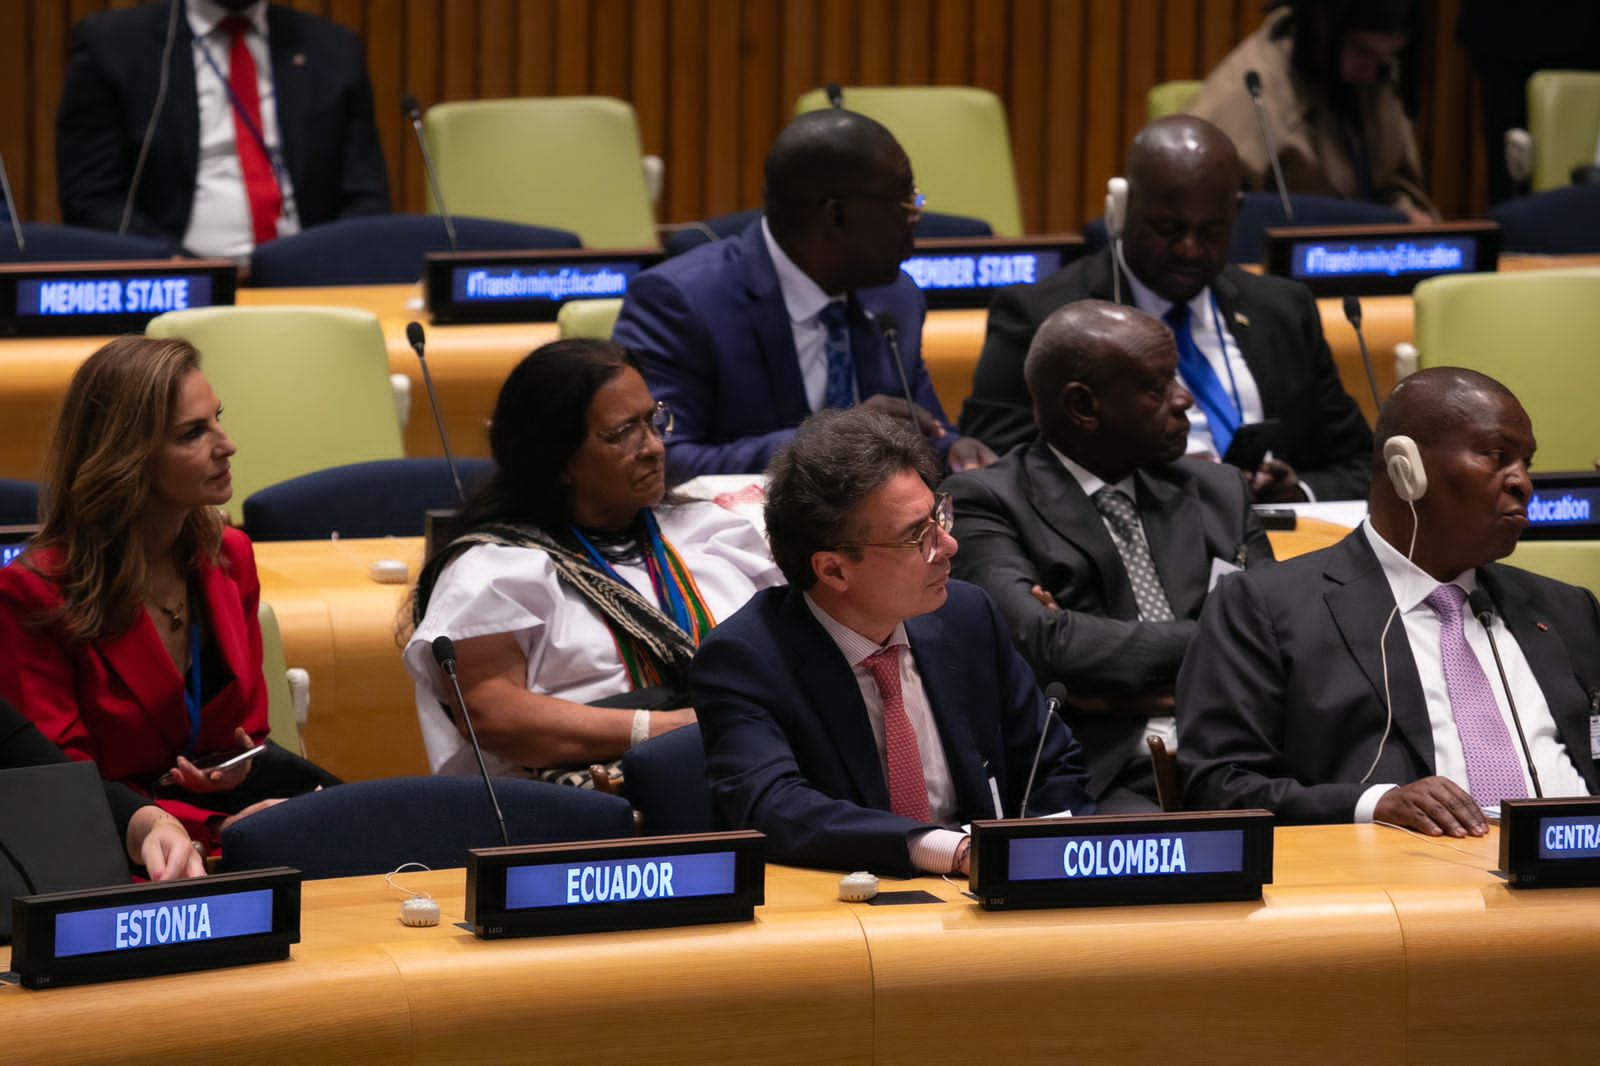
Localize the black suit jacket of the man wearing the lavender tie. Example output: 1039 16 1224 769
1178 530 1600 823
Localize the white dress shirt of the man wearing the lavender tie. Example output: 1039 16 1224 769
1355 519 1589 821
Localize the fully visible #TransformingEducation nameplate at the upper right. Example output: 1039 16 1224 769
1262 222 1501 296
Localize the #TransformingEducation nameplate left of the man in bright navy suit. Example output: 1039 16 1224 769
422 248 662 325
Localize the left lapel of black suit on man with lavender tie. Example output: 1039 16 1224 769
1323 528 1434 768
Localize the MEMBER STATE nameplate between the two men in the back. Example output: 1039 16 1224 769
901 235 1085 311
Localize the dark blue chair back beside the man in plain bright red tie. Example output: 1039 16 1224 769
250 214 582 288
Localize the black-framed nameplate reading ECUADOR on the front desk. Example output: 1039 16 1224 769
467 831 766 940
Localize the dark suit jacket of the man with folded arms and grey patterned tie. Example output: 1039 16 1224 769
944 440 1272 797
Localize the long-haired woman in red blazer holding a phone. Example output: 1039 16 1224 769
0 336 310 850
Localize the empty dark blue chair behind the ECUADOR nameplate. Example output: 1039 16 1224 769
221 778 634 877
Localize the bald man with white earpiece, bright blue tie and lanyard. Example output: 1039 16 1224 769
962 115 1373 503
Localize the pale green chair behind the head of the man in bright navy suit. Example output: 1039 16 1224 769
790 86 1022 237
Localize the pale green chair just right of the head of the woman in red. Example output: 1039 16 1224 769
146 307 405 522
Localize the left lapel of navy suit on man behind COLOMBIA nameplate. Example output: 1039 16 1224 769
781 589 890 810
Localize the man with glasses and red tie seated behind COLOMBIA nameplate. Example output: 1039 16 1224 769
690 408 1094 876
